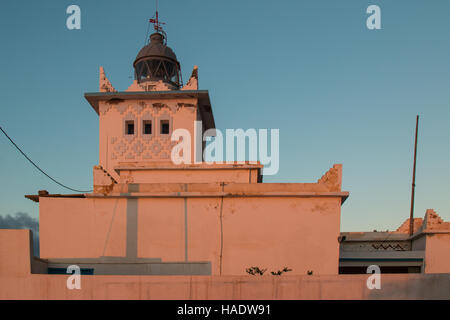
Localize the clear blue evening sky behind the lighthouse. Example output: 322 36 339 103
0 0 450 231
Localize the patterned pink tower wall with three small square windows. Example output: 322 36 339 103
99 98 199 179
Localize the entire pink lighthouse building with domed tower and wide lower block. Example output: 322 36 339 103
32 11 348 275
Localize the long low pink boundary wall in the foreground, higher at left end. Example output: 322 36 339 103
0 230 450 300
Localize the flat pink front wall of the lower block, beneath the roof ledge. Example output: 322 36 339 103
40 196 341 275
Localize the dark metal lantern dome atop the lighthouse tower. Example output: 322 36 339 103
133 33 181 89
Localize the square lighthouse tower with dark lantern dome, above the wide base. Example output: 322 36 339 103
85 28 243 190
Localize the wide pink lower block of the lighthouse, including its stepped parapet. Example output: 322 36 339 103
40 164 348 275
